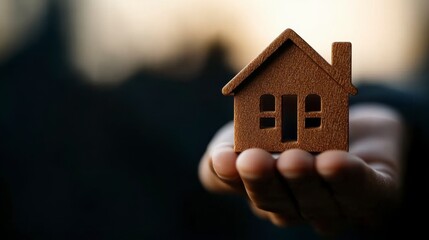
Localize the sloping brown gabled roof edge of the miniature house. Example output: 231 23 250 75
222 28 357 95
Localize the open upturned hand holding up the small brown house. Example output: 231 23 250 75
199 105 405 234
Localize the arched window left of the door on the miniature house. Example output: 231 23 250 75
259 94 276 129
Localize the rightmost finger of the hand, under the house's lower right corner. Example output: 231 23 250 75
315 151 397 221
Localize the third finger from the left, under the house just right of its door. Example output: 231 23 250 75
277 149 343 232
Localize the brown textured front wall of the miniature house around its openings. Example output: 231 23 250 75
234 41 348 152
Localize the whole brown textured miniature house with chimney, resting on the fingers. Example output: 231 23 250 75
222 29 357 152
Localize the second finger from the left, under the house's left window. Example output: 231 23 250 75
237 149 302 224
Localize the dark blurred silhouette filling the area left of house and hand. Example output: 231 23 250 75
0 4 314 239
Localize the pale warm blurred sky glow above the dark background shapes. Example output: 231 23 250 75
0 0 429 83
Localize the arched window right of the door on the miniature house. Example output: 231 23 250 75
304 94 322 128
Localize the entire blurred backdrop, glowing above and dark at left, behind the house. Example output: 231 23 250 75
0 0 429 239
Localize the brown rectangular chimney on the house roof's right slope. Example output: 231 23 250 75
332 42 352 86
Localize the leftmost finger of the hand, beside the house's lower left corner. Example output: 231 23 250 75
199 144 245 194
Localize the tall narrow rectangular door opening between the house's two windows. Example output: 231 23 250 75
281 94 298 142
